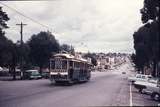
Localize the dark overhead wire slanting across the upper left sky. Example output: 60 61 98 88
0 2 52 30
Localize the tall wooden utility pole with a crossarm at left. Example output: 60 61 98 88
16 22 27 79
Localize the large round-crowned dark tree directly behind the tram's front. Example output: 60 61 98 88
27 32 60 73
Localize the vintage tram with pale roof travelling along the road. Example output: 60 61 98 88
50 53 92 84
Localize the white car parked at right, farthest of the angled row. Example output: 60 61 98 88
128 74 152 83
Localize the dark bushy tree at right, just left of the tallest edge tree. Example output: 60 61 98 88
133 23 158 73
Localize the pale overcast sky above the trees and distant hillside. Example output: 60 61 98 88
0 0 143 53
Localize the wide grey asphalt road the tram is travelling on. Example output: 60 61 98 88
0 63 158 107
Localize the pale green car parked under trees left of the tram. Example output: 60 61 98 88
24 70 42 79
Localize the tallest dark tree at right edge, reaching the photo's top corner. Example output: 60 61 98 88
141 0 160 76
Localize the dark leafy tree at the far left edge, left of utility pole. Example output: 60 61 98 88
0 7 17 79
